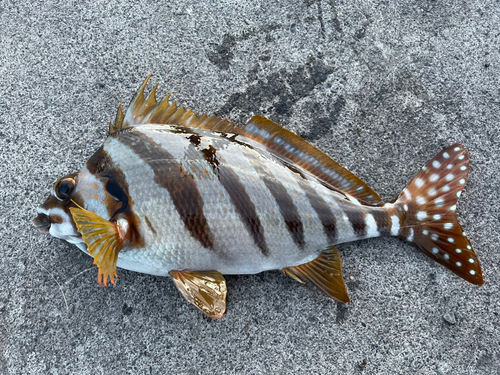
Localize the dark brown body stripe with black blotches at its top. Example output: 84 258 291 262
189 135 269 257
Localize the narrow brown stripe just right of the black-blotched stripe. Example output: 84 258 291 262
242 148 306 249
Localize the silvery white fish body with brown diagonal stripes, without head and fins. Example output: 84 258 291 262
86 124 390 275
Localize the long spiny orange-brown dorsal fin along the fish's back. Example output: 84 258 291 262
109 74 381 205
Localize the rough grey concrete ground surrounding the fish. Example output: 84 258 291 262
0 0 500 375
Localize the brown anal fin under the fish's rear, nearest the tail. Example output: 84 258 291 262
283 247 349 303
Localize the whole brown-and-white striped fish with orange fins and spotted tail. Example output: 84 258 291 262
33 75 484 319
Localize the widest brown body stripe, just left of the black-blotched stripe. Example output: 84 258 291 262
117 130 214 250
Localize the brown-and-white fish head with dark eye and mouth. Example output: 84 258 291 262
33 168 127 247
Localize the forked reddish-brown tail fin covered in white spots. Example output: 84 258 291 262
395 143 484 285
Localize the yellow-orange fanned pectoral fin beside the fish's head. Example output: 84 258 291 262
69 203 123 286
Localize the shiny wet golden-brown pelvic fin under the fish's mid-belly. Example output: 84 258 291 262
170 271 227 319
